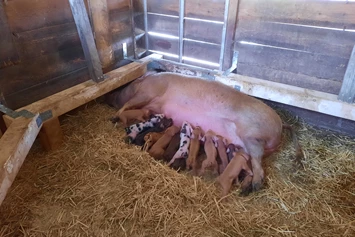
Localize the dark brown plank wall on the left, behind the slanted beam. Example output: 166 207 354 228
0 0 133 109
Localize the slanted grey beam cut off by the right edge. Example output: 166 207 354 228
338 45 355 103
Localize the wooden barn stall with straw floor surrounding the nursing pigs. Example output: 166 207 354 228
0 0 355 236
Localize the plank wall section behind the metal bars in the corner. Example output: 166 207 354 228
135 0 225 69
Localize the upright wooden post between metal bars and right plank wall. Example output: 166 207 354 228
220 0 239 71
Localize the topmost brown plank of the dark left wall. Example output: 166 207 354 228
5 0 73 33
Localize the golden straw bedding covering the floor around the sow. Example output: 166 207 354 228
0 103 355 237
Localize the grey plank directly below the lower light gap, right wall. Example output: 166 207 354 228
236 43 348 81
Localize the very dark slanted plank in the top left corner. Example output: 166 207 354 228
0 1 20 68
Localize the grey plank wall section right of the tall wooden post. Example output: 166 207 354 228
235 0 355 94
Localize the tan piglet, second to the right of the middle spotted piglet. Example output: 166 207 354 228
199 130 218 176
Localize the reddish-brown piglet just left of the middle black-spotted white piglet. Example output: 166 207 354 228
148 125 180 160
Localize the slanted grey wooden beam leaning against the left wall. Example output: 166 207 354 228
69 0 104 82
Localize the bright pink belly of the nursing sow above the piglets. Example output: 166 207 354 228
161 104 244 147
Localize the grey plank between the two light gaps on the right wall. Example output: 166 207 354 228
235 19 355 58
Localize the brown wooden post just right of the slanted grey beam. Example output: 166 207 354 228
89 0 114 69
